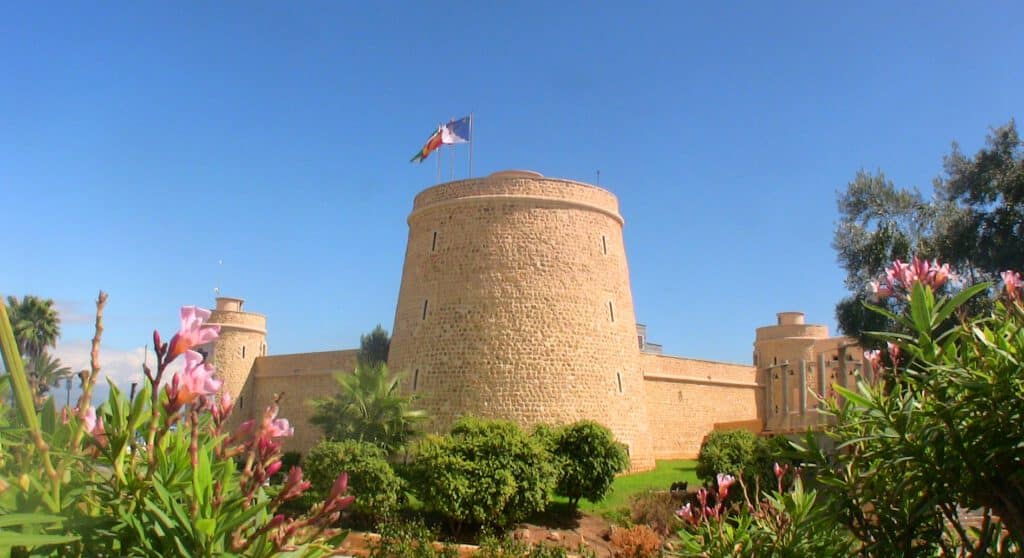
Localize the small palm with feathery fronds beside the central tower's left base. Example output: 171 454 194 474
309 363 426 453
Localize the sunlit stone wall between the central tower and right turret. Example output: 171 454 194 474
640 354 764 459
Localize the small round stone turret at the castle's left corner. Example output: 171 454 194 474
204 297 266 419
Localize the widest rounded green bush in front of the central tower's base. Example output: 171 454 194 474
411 418 556 529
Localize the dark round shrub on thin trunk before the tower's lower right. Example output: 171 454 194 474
552 421 630 506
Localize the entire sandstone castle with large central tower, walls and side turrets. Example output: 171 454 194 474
206 171 858 470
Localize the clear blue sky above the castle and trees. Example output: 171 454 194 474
0 2 1024 391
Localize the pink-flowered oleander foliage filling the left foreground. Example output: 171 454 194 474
0 294 349 557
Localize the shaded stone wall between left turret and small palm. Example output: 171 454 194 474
249 349 358 455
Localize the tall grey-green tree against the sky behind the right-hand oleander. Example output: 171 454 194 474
833 120 1024 346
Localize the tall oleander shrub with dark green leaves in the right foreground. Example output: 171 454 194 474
805 283 1024 556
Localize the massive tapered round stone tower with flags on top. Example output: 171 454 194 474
388 171 654 470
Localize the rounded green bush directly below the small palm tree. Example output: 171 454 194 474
304 440 401 523
